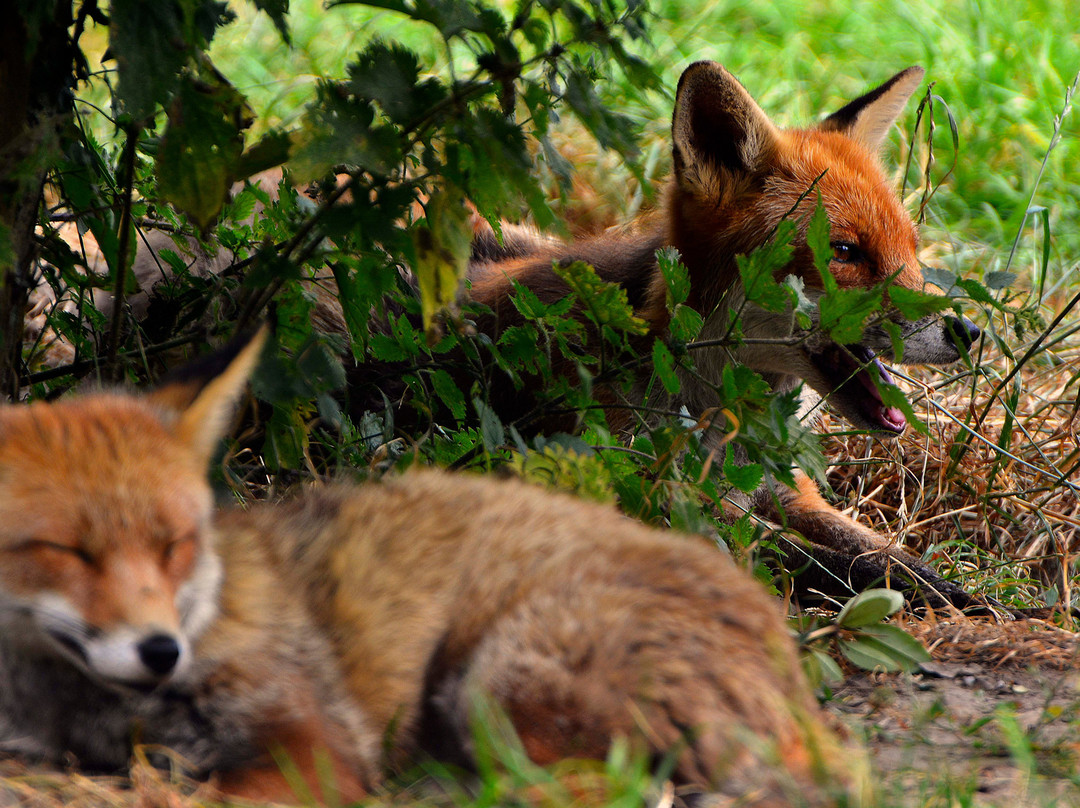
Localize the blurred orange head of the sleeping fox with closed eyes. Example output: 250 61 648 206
0 334 265 687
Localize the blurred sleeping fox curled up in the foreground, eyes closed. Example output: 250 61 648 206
0 332 867 806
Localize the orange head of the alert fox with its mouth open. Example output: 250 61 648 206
670 62 980 433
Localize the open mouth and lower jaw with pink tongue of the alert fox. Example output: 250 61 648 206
812 345 907 435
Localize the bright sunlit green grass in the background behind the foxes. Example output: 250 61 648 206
212 0 1080 282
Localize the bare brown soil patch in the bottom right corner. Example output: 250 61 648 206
828 619 1080 808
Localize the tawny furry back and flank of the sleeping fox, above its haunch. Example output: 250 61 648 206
227 471 816 769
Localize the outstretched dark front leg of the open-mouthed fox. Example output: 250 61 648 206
755 471 993 610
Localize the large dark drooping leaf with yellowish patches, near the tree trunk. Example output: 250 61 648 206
154 73 251 229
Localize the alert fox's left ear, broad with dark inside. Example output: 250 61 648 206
672 62 780 194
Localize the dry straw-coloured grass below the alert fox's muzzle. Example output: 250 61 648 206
826 328 1080 605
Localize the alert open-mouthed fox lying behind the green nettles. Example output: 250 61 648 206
468 62 984 610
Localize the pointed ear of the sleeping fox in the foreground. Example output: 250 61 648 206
147 326 269 463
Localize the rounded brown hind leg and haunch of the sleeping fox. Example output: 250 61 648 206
435 574 843 805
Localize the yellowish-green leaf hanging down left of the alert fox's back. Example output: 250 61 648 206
413 189 472 331
